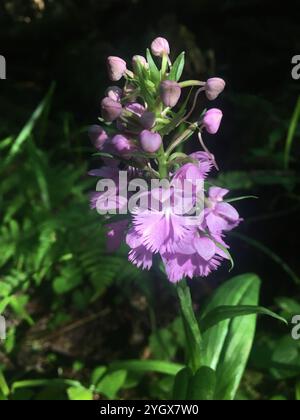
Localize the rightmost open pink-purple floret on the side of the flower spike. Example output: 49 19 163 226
205 187 241 234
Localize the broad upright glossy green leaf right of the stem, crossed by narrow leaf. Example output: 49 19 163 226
202 274 260 400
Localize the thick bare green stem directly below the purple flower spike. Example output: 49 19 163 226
177 280 203 373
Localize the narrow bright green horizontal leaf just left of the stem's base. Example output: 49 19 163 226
110 360 184 376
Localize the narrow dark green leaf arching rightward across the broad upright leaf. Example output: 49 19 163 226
199 305 288 334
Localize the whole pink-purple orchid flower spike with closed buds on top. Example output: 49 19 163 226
89 37 241 282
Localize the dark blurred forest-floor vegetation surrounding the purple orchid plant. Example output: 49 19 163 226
0 0 300 400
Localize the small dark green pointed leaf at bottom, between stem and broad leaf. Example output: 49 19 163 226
188 366 216 401
